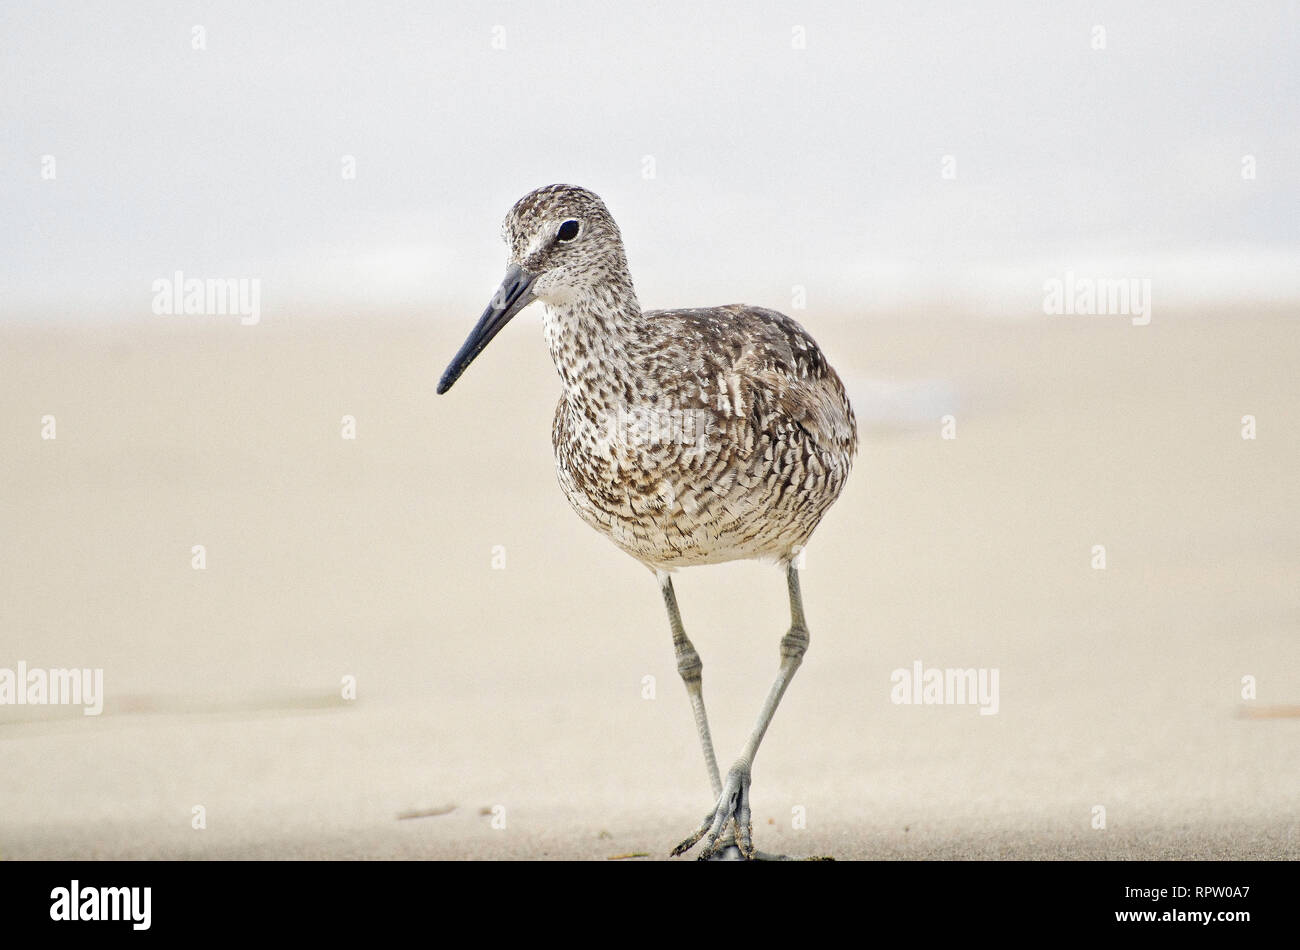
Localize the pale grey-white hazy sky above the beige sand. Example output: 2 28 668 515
0 0 1300 322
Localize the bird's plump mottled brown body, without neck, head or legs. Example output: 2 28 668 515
554 304 857 568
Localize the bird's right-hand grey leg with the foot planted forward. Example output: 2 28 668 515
672 563 809 859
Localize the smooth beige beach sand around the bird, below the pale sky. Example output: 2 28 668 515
0 309 1300 860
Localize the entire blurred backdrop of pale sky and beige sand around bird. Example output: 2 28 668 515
0 3 1300 858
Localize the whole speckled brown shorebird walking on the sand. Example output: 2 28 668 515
438 185 858 859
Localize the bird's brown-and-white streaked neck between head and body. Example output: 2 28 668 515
542 281 642 396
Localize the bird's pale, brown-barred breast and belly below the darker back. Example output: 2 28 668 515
553 394 849 569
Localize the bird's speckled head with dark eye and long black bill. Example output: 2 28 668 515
438 185 628 392
